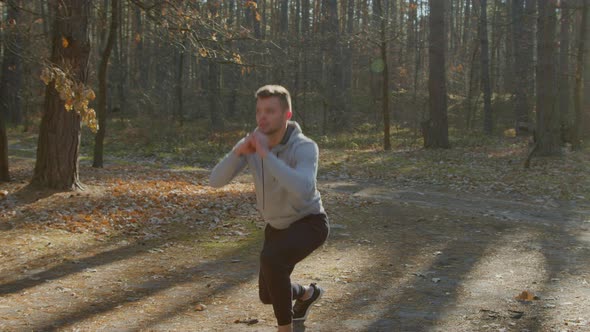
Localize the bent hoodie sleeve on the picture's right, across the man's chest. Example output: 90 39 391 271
264 142 319 198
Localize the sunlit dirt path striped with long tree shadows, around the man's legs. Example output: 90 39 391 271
0 176 590 332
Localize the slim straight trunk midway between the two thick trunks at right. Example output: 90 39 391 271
479 0 493 135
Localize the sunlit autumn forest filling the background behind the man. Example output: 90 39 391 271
0 0 590 187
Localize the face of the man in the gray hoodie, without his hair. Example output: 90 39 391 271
256 96 288 136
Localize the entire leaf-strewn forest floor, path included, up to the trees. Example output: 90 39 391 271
0 128 590 332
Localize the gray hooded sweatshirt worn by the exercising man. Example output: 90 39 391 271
209 121 324 229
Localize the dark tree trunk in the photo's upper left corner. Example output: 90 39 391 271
0 1 23 124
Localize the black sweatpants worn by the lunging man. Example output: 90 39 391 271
258 214 330 325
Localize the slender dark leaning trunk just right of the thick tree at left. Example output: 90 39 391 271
92 0 119 168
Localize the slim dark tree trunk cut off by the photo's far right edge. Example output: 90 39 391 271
572 0 590 150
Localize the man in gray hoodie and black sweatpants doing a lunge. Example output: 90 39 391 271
210 85 329 332
